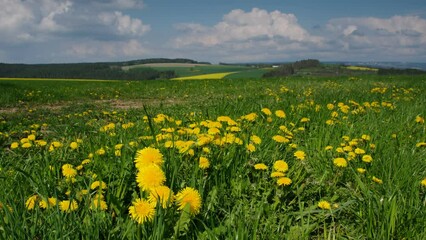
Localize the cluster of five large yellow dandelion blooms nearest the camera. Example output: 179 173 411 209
129 147 202 224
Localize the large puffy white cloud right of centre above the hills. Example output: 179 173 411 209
174 8 322 47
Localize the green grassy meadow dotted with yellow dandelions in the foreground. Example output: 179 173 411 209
0 75 426 239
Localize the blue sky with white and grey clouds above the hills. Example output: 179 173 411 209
0 0 426 63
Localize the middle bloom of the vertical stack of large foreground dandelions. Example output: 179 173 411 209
136 164 166 190
